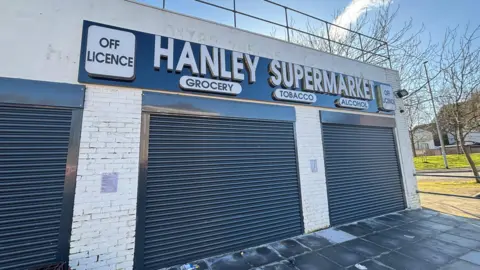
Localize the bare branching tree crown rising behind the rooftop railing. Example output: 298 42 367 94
289 4 437 99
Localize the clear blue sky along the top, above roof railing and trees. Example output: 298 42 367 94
140 0 480 45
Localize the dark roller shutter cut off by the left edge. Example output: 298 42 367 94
0 105 72 269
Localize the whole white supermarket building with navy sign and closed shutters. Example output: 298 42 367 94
0 0 419 269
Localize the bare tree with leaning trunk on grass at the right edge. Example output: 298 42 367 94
439 25 480 183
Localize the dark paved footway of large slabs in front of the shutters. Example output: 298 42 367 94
164 210 480 270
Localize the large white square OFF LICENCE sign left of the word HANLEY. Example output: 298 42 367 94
85 25 135 80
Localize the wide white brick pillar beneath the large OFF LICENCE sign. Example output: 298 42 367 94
70 86 142 269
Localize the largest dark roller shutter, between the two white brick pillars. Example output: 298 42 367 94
139 115 303 269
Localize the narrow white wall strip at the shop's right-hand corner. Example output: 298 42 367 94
385 70 420 209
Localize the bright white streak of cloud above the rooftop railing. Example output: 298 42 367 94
331 0 392 40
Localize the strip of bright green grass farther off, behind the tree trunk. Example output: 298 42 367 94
414 153 480 170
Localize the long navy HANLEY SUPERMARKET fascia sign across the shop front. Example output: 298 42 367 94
78 21 395 112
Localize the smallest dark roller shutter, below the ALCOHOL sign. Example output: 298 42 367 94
322 124 405 225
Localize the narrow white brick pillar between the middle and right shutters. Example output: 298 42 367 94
295 107 330 232
